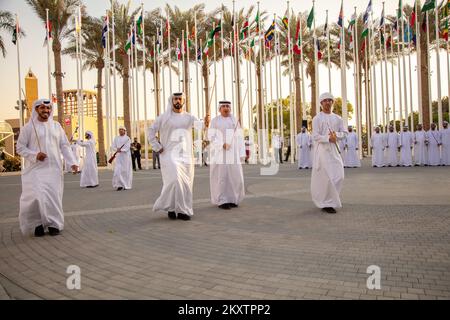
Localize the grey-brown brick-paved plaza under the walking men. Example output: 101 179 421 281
0 160 450 299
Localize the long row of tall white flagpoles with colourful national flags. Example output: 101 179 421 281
15 0 450 168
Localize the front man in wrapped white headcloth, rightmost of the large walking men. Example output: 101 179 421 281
311 93 347 214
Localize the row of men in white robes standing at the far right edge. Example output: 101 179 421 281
371 121 450 167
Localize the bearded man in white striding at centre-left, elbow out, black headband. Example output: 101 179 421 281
148 93 201 220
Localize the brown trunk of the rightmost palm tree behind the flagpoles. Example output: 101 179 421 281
419 15 430 130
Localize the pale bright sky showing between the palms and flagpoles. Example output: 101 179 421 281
0 0 449 130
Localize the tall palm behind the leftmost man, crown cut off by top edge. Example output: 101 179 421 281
26 0 84 125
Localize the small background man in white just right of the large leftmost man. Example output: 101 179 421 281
77 131 98 188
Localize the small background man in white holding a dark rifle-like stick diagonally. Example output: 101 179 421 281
111 126 133 191
